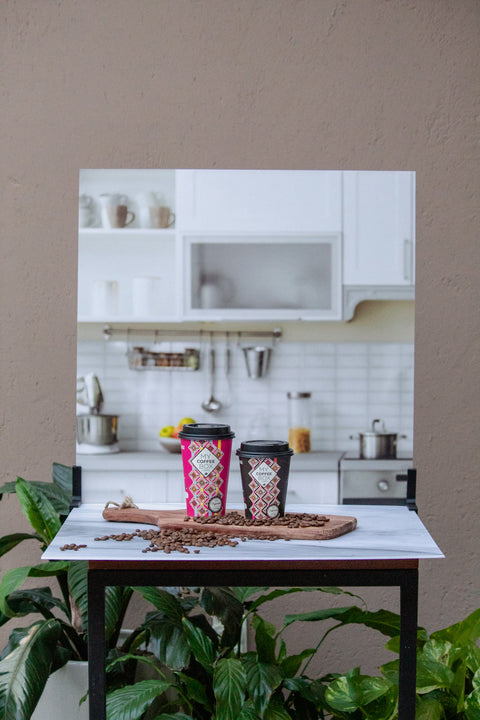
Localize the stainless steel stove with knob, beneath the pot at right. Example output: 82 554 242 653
339 452 415 505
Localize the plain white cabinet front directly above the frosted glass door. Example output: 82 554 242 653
176 169 342 233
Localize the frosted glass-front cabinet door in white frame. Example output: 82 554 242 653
182 233 342 320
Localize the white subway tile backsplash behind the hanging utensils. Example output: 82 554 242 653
77 341 414 452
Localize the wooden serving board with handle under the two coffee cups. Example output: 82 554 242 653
103 508 357 540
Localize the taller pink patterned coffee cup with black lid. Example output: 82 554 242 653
178 423 235 517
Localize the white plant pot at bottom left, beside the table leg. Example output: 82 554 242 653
31 660 89 720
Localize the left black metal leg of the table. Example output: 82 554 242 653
88 570 106 720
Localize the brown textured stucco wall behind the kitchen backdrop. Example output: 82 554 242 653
0 0 480 668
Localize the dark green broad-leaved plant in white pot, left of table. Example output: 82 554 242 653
0 463 134 720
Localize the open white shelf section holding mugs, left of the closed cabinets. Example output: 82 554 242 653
78 170 179 322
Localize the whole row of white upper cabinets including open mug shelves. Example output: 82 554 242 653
78 169 415 323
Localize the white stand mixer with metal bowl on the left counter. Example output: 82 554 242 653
76 373 120 455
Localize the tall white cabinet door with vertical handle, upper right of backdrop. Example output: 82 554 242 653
343 171 415 288
